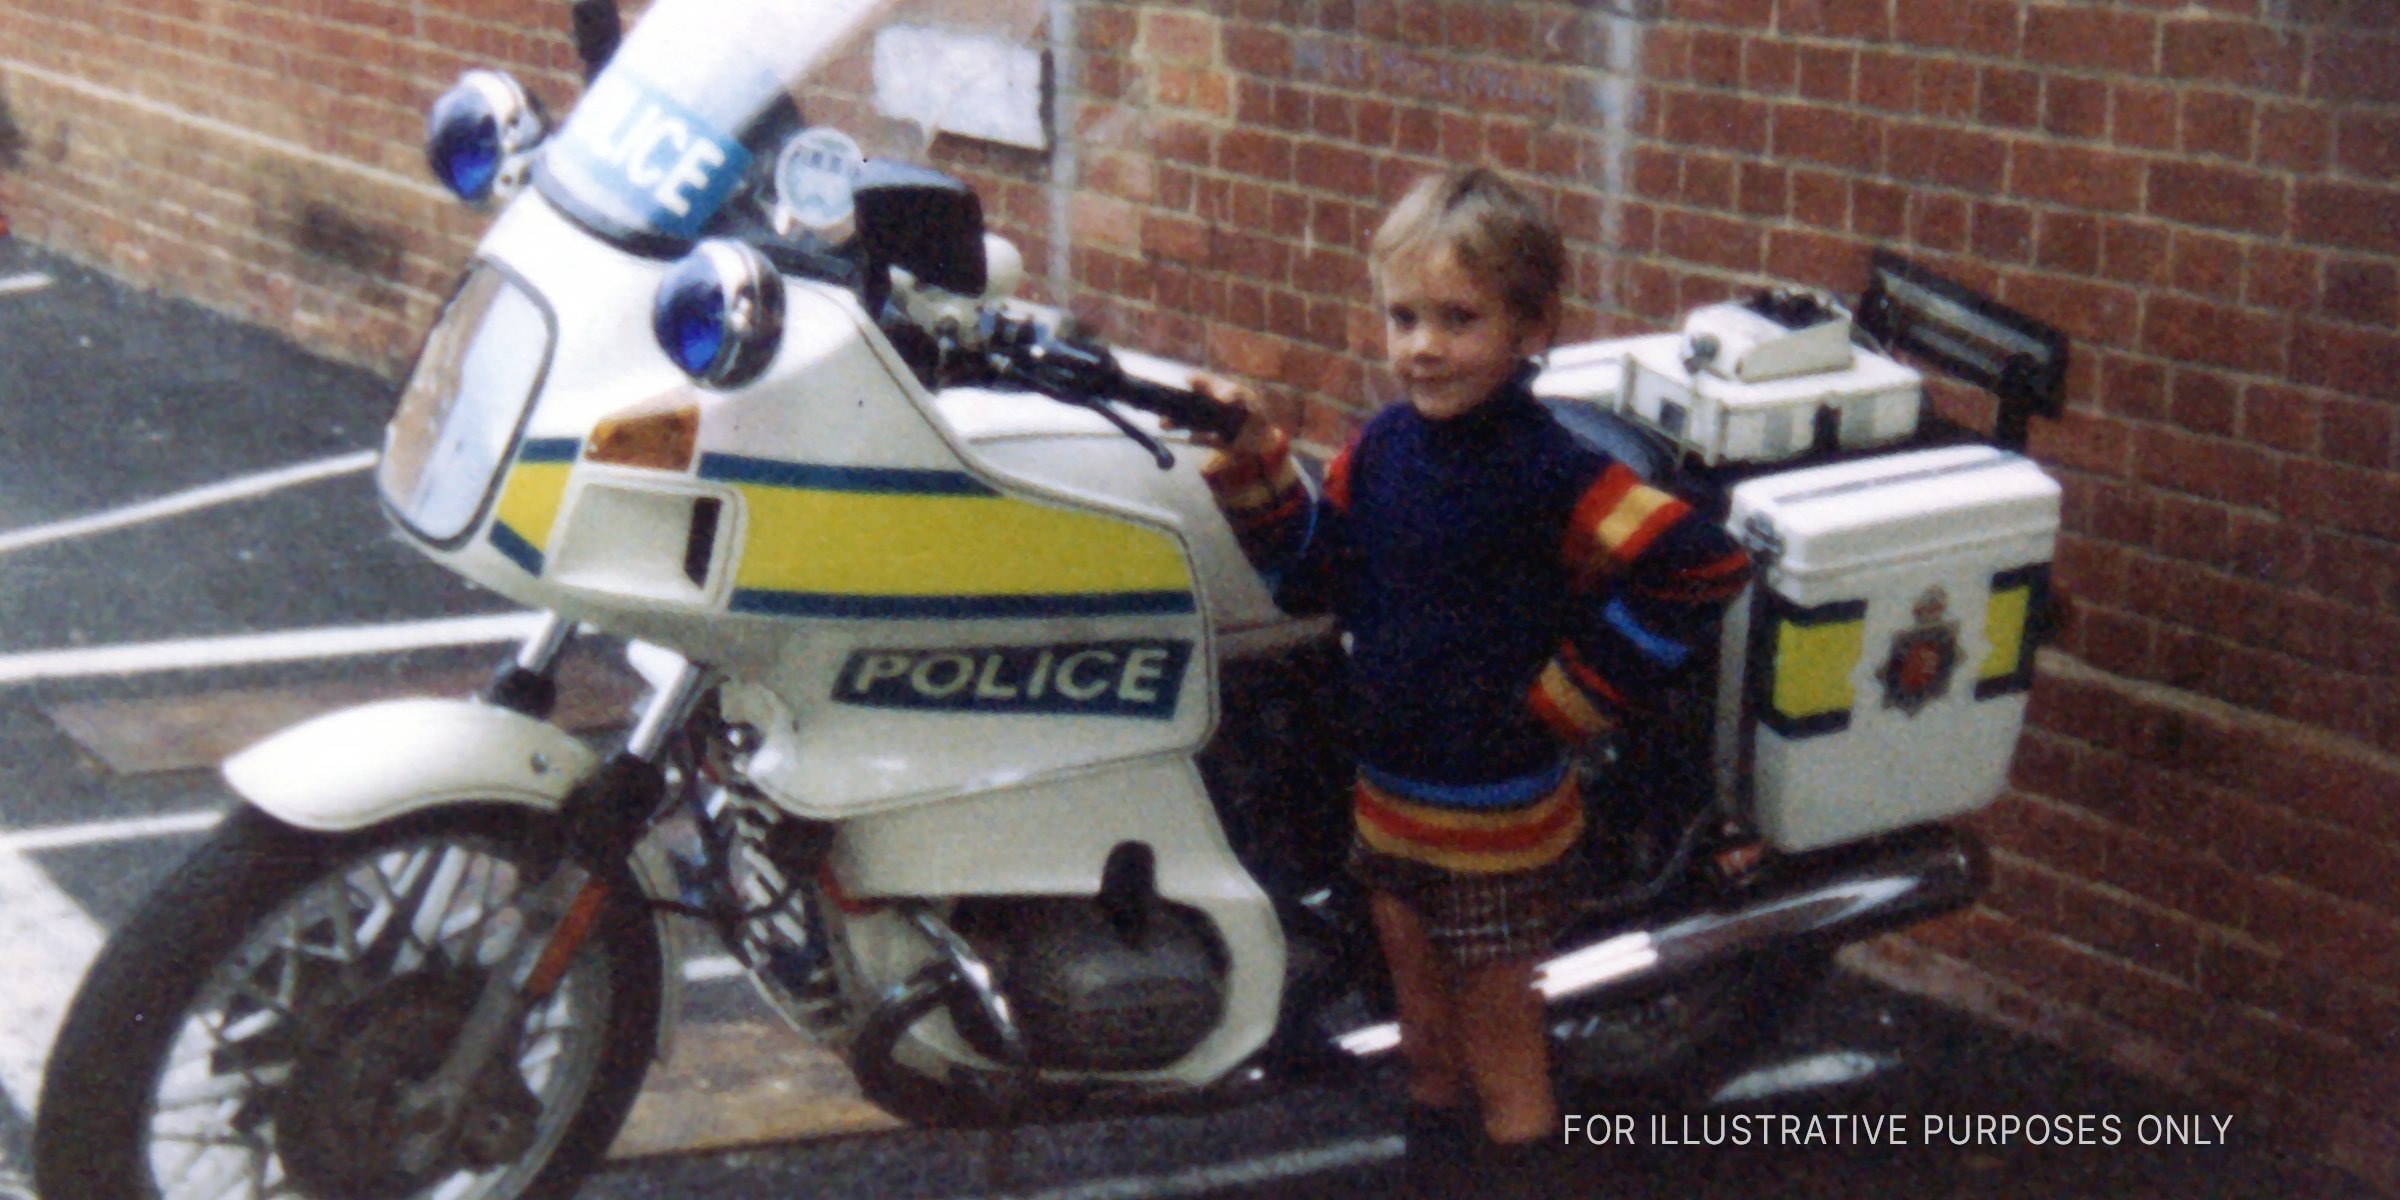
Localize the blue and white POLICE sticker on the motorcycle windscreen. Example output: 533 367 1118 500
545 70 749 238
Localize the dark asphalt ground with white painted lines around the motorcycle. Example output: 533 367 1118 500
0 226 2376 1200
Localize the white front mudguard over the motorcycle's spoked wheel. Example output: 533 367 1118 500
223 698 684 1058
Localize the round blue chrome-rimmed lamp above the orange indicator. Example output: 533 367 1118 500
650 238 782 389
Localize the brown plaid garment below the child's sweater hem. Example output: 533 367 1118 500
1346 835 1582 972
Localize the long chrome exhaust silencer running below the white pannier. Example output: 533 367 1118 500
1334 826 1985 1056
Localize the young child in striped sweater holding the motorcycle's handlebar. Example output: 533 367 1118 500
1193 168 1750 1195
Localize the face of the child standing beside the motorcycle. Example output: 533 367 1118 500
1382 247 1543 420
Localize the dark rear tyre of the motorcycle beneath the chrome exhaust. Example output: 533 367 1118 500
1550 950 1831 1104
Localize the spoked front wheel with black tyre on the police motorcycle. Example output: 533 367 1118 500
34 806 660 1200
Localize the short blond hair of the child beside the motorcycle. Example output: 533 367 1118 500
1366 166 1567 326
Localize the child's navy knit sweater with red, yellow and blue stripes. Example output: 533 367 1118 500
1210 374 1750 874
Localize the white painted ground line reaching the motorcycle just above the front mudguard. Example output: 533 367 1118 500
0 612 542 686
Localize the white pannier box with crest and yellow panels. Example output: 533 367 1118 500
1716 446 2059 852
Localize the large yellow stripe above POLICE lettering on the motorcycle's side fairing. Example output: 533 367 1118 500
734 485 1190 595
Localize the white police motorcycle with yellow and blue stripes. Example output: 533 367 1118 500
34 0 2066 1200
